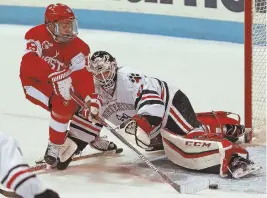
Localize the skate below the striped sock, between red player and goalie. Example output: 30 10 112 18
90 136 123 153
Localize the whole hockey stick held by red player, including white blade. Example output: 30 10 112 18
71 92 214 194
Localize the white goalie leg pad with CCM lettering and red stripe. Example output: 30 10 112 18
161 129 221 172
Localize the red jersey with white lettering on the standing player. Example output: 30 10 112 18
20 24 94 101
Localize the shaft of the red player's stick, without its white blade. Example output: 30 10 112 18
71 93 186 193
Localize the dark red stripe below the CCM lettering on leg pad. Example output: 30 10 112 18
163 138 219 159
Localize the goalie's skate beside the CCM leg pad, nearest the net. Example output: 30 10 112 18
228 154 261 179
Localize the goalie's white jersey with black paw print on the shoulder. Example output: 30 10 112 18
96 67 178 138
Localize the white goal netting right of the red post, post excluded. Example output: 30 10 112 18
252 0 267 140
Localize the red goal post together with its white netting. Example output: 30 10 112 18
244 0 267 138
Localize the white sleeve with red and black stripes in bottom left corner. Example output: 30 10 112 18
0 132 45 198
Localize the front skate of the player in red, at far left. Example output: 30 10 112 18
44 142 61 166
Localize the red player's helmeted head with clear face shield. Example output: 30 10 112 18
45 3 78 43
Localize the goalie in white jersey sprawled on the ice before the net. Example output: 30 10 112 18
77 51 260 178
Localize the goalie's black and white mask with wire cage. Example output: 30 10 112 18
89 51 117 95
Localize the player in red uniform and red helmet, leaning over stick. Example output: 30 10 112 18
20 3 119 169
